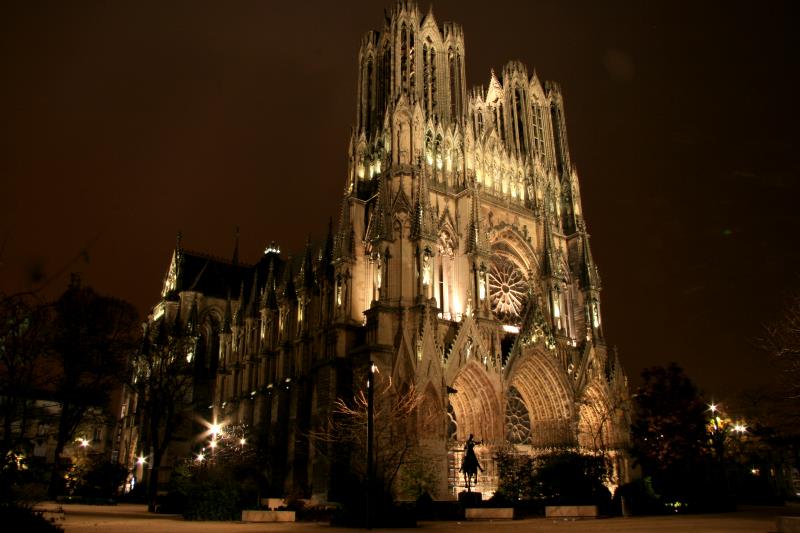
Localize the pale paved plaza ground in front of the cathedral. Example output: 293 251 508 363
32 504 800 533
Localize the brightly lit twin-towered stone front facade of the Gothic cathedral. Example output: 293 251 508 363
333 1 627 496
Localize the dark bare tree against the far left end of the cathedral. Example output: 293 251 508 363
129 320 196 511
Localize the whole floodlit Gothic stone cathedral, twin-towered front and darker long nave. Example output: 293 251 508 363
122 0 629 500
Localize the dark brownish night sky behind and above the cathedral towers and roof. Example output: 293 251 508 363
0 0 800 398
